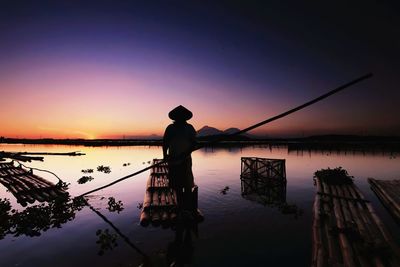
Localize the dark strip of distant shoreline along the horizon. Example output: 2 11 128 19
0 135 400 151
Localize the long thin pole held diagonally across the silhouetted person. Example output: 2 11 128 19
78 73 372 197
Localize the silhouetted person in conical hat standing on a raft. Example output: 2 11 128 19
163 106 196 211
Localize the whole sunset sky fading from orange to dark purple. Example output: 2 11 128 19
0 1 400 138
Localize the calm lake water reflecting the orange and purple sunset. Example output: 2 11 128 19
0 145 400 267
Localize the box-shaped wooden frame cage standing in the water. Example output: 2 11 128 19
240 157 286 203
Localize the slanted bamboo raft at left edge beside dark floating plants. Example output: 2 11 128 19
0 162 68 207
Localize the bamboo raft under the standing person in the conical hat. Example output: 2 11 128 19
140 159 203 228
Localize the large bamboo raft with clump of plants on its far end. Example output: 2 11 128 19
311 173 400 267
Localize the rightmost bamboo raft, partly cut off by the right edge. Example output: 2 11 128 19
368 178 400 224
